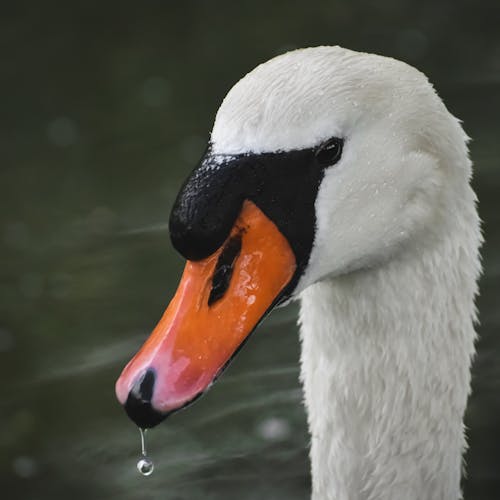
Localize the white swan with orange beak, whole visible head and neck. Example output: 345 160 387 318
116 46 481 500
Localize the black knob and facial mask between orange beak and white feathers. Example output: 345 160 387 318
169 138 343 298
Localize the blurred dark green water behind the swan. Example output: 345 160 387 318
0 0 500 500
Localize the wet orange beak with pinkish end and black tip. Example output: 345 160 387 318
116 201 296 427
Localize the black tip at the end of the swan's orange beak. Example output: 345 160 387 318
125 368 167 429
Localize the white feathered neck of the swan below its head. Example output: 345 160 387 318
300 239 477 500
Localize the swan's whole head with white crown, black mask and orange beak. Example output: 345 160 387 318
116 47 470 427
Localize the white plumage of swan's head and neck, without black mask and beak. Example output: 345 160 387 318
212 47 481 500
